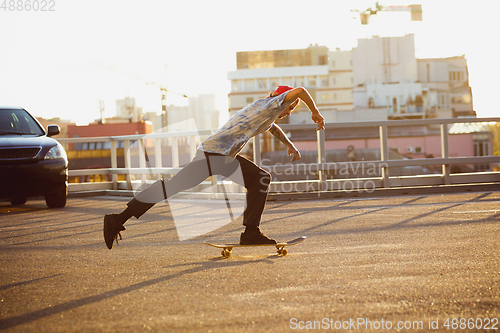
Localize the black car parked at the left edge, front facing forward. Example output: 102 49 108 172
0 107 68 208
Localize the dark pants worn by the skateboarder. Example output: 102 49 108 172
127 150 271 226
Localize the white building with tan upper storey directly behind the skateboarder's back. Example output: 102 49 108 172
228 45 353 123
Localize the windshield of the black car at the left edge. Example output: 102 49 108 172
0 110 44 135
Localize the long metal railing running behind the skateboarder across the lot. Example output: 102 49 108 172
59 118 500 194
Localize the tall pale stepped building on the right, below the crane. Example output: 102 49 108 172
352 35 476 120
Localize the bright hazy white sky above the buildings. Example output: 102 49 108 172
0 0 500 124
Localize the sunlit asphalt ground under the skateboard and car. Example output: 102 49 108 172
0 192 500 332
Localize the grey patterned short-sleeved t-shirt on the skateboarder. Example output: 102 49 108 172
198 91 291 157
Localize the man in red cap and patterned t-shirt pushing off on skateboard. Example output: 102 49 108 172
103 86 325 249
